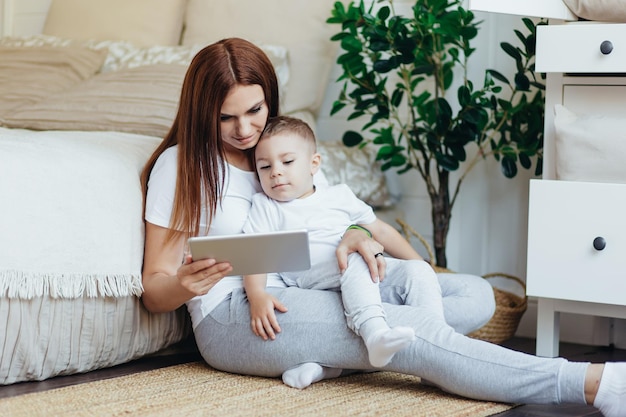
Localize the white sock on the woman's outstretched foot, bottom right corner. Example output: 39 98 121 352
593 362 626 417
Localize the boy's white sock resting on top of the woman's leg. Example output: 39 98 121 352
365 326 415 368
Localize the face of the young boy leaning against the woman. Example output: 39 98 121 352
254 132 321 201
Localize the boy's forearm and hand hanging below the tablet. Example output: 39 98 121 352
243 274 287 340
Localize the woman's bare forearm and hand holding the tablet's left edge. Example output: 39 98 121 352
141 222 232 313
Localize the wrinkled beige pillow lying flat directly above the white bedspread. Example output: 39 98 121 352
1 64 187 137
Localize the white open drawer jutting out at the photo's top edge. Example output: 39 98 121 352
469 0 578 20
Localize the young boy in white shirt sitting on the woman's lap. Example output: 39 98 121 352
244 117 443 388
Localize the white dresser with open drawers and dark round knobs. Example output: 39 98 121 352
470 0 626 357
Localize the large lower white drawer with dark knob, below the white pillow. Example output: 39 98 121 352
526 180 626 305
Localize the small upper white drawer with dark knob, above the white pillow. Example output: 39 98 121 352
535 22 626 74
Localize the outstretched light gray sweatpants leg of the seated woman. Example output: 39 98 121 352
195 277 588 404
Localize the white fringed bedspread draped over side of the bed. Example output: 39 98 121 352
0 128 161 299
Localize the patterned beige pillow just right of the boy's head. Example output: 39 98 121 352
318 141 394 208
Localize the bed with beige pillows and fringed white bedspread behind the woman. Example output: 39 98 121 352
0 0 400 384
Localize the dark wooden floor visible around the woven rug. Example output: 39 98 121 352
0 338 626 417
